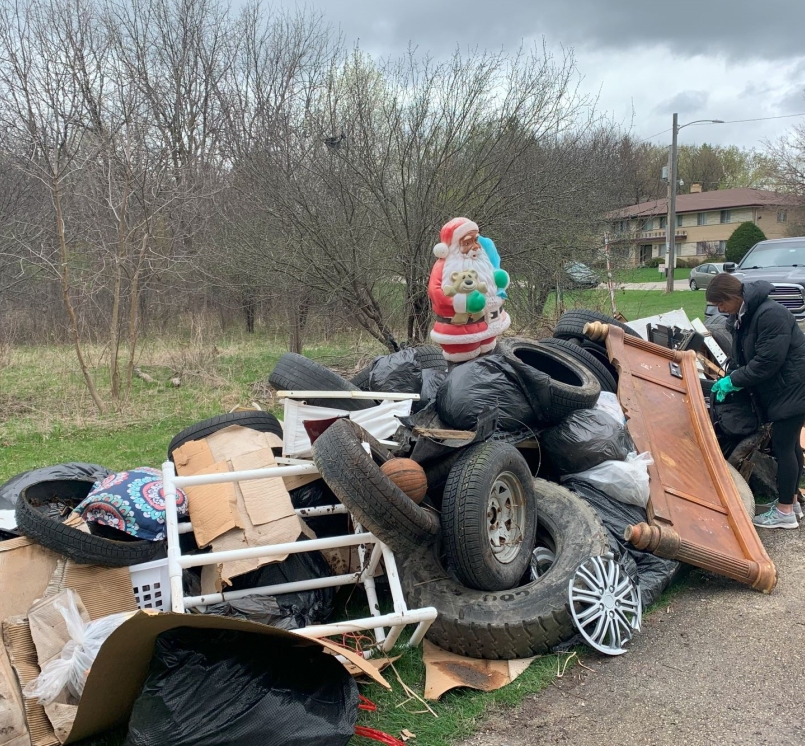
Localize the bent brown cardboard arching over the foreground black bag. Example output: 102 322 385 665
67 611 391 743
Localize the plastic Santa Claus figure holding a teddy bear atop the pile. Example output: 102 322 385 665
428 218 511 362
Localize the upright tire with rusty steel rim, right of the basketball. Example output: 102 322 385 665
442 443 537 591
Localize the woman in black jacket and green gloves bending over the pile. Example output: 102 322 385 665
707 274 805 528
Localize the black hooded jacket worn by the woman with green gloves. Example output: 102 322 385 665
730 281 805 422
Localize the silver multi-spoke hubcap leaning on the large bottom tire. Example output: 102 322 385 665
568 554 643 655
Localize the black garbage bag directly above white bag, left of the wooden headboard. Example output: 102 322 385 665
539 409 637 474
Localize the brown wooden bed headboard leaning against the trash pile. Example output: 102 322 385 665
600 324 777 593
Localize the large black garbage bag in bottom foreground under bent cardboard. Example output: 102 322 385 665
124 627 358 746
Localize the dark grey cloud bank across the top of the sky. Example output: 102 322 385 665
302 0 805 62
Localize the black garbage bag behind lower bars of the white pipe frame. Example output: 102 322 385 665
205 552 335 629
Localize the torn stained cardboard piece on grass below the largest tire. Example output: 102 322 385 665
422 640 538 699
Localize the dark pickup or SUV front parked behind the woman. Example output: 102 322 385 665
724 236 805 330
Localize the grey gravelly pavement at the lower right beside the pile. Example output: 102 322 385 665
464 529 805 746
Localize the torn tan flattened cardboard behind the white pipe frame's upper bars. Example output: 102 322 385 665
173 425 301 593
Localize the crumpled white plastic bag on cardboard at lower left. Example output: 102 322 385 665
24 591 131 705
